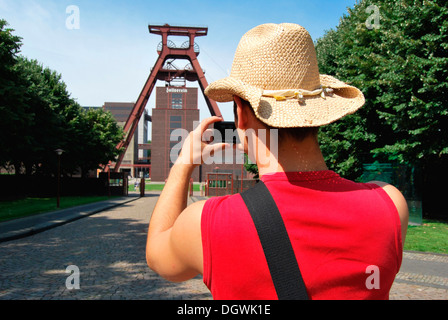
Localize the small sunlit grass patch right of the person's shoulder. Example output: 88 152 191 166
404 219 448 254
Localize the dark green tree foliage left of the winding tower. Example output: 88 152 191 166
0 20 123 175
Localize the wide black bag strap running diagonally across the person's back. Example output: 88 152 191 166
241 181 309 300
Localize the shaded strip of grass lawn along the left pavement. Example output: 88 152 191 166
0 196 114 222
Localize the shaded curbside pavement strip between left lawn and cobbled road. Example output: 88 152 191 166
0 197 140 243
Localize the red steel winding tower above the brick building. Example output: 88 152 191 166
113 24 221 172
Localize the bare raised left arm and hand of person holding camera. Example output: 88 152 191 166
146 117 227 281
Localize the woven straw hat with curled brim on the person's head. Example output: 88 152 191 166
205 23 365 128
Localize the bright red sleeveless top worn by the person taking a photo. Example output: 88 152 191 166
201 171 402 300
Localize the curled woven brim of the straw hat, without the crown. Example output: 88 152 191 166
205 75 365 128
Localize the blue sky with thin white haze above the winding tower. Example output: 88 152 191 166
0 0 356 120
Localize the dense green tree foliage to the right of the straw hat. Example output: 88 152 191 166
316 0 448 178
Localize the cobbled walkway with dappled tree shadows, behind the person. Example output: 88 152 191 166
0 194 448 300
